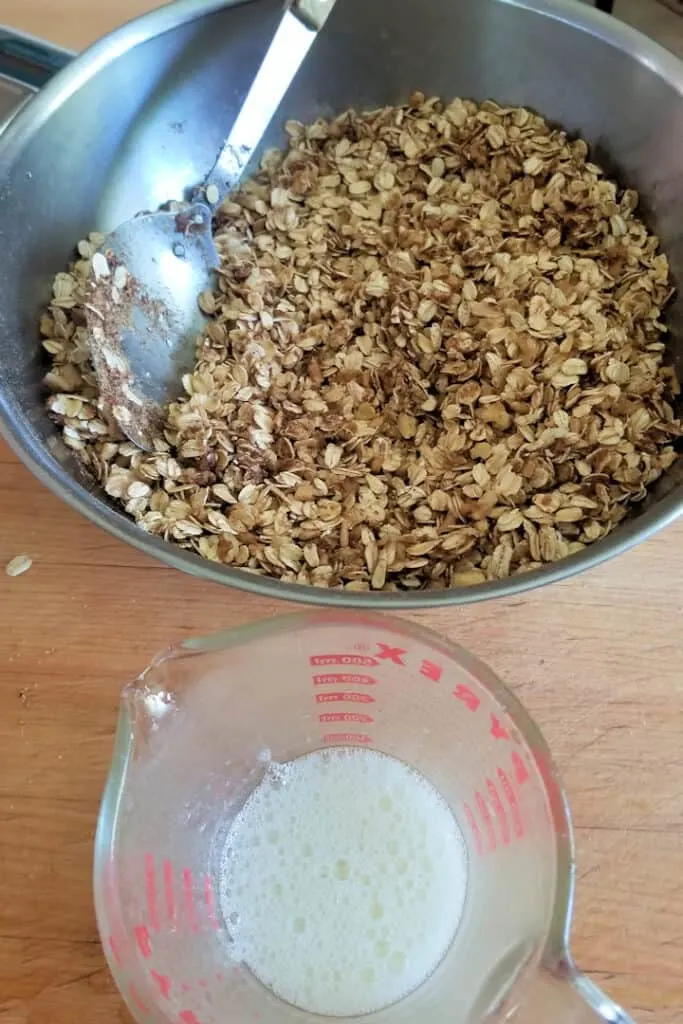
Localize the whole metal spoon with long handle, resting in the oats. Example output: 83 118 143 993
85 0 335 451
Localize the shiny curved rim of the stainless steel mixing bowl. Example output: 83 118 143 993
0 0 683 611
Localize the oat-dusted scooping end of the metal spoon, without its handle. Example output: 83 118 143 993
85 203 218 452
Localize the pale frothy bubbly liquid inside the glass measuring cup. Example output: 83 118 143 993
221 748 467 1017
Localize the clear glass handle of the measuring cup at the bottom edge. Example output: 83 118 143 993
508 958 635 1024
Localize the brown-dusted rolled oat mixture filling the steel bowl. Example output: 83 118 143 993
41 94 682 590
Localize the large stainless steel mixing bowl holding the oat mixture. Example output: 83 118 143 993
0 0 683 609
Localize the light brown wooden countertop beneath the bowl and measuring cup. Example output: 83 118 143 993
0 0 683 1024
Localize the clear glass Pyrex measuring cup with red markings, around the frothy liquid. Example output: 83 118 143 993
94 612 632 1024
